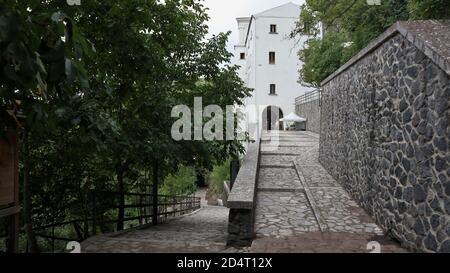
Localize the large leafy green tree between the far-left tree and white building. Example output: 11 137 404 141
72 0 248 229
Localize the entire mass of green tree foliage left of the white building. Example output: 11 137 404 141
0 0 250 252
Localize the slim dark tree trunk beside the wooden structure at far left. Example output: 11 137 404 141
22 131 40 253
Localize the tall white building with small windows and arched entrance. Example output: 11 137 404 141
234 3 312 135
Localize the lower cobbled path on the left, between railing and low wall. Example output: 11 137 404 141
82 206 237 253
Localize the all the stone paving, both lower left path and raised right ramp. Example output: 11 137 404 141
82 132 404 253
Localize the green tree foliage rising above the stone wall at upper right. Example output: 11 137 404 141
291 0 450 87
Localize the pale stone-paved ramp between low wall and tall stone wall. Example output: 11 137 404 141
251 131 404 252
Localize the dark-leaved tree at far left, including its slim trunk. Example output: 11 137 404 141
0 0 99 251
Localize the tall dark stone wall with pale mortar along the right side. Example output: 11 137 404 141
320 21 450 252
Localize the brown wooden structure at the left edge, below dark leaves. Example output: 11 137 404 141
0 132 20 252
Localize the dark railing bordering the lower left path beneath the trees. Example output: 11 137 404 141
29 191 201 252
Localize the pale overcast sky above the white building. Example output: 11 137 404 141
203 0 304 51
